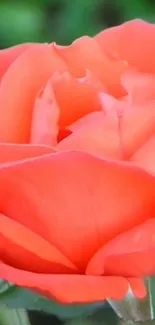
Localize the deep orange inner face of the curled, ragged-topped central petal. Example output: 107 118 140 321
51 73 104 129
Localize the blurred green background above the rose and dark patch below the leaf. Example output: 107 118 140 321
0 0 155 325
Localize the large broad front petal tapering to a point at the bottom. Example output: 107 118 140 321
0 152 155 271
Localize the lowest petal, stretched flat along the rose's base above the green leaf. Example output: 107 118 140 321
0 263 146 303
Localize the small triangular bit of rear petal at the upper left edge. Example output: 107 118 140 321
0 44 34 80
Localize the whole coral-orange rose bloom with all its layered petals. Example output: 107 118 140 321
0 20 155 303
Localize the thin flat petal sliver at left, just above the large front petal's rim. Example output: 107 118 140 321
0 143 54 165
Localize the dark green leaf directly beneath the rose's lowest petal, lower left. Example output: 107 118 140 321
0 284 104 319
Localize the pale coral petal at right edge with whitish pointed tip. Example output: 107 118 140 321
102 91 155 160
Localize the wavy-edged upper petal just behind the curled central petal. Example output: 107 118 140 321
55 36 128 97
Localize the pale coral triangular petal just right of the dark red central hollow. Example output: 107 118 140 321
55 112 123 159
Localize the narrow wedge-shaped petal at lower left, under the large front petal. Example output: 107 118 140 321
0 214 77 273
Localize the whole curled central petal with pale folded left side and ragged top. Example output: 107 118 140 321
31 72 103 145
